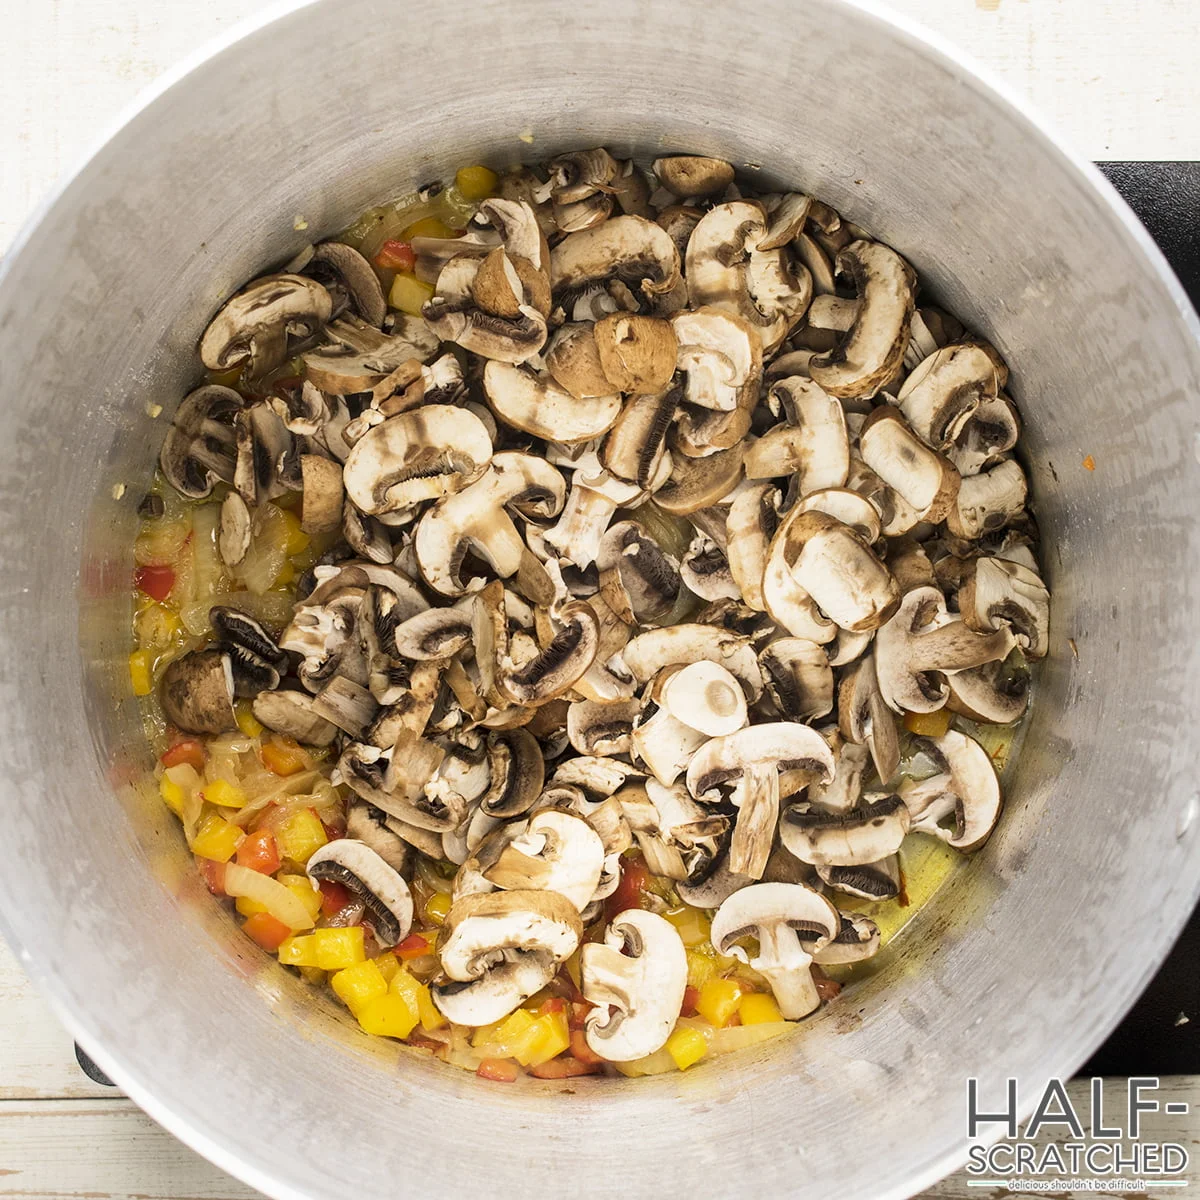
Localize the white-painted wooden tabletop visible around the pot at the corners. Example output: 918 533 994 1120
0 0 1200 1200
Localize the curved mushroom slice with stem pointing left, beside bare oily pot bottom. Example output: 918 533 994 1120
900 730 1002 853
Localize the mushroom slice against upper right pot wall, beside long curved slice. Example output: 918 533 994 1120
896 342 1000 454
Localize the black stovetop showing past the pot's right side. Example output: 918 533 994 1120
1079 162 1200 1075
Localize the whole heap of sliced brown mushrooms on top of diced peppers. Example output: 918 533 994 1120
152 149 1049 1061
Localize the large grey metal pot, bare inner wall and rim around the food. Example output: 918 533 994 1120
0 0 1200 1200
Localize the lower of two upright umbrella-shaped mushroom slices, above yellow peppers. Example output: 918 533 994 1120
712 883 841 1021
